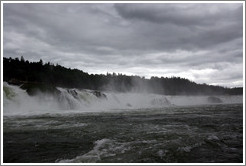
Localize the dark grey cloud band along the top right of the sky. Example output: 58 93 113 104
115 3 243 26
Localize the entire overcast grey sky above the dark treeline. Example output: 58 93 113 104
3 3 244 87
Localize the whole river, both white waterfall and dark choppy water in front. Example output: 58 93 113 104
3 82 243 163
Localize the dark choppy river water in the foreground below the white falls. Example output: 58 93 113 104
3 104 243 163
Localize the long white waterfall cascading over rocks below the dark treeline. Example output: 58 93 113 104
3 82 243 115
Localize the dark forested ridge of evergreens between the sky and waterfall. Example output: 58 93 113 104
3 57 243 95
